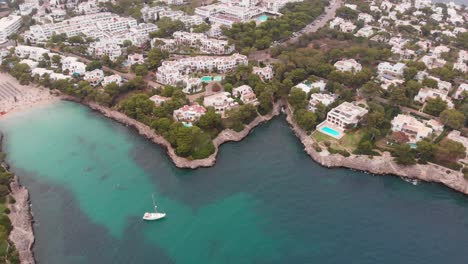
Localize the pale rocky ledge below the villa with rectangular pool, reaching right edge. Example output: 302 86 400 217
285 103 468 194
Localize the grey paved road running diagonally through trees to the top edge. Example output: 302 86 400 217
249 0 343 61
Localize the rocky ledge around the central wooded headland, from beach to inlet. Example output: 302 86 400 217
60 95 282 169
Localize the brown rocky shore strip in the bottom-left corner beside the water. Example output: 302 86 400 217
0 134 35 264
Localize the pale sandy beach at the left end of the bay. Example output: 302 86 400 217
0 73 60 117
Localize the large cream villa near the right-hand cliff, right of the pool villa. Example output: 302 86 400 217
391 114 433 143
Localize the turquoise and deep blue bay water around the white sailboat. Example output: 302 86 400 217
0 102 468 264
